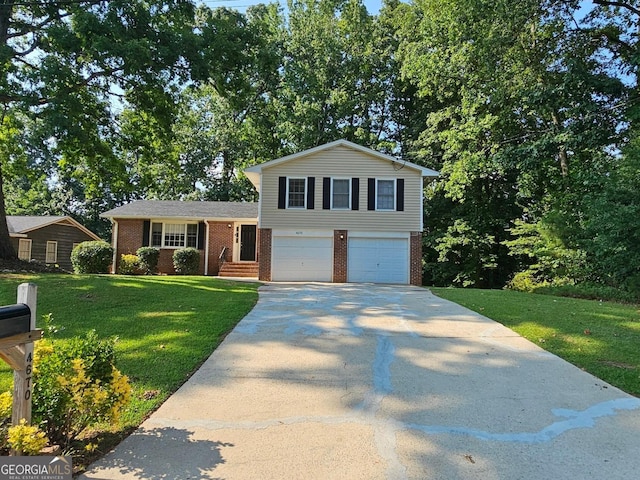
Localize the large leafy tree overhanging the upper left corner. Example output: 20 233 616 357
0 0 252 258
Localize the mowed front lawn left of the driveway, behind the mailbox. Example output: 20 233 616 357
0 274 259 430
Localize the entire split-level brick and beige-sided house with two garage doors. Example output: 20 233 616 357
102 140 438 285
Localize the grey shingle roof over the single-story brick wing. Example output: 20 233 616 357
100 200 258 220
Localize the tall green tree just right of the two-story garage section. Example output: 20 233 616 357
394 0 625 286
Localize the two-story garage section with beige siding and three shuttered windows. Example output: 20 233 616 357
245 140 438 285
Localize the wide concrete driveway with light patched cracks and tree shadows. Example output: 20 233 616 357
81 284 640 480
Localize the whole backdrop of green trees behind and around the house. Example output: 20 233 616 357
0 0 640 295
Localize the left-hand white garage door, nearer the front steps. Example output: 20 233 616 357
271 236 333 282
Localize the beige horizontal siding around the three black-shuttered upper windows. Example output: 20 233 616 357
260 147 422 232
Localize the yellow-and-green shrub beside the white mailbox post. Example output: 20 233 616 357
33 331 131 446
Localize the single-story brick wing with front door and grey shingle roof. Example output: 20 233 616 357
101 200 258 277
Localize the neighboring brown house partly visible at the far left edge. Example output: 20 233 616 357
7 216 100 270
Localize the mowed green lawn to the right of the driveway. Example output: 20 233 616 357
430 288 640 396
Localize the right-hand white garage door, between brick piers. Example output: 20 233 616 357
347 237 409 284
